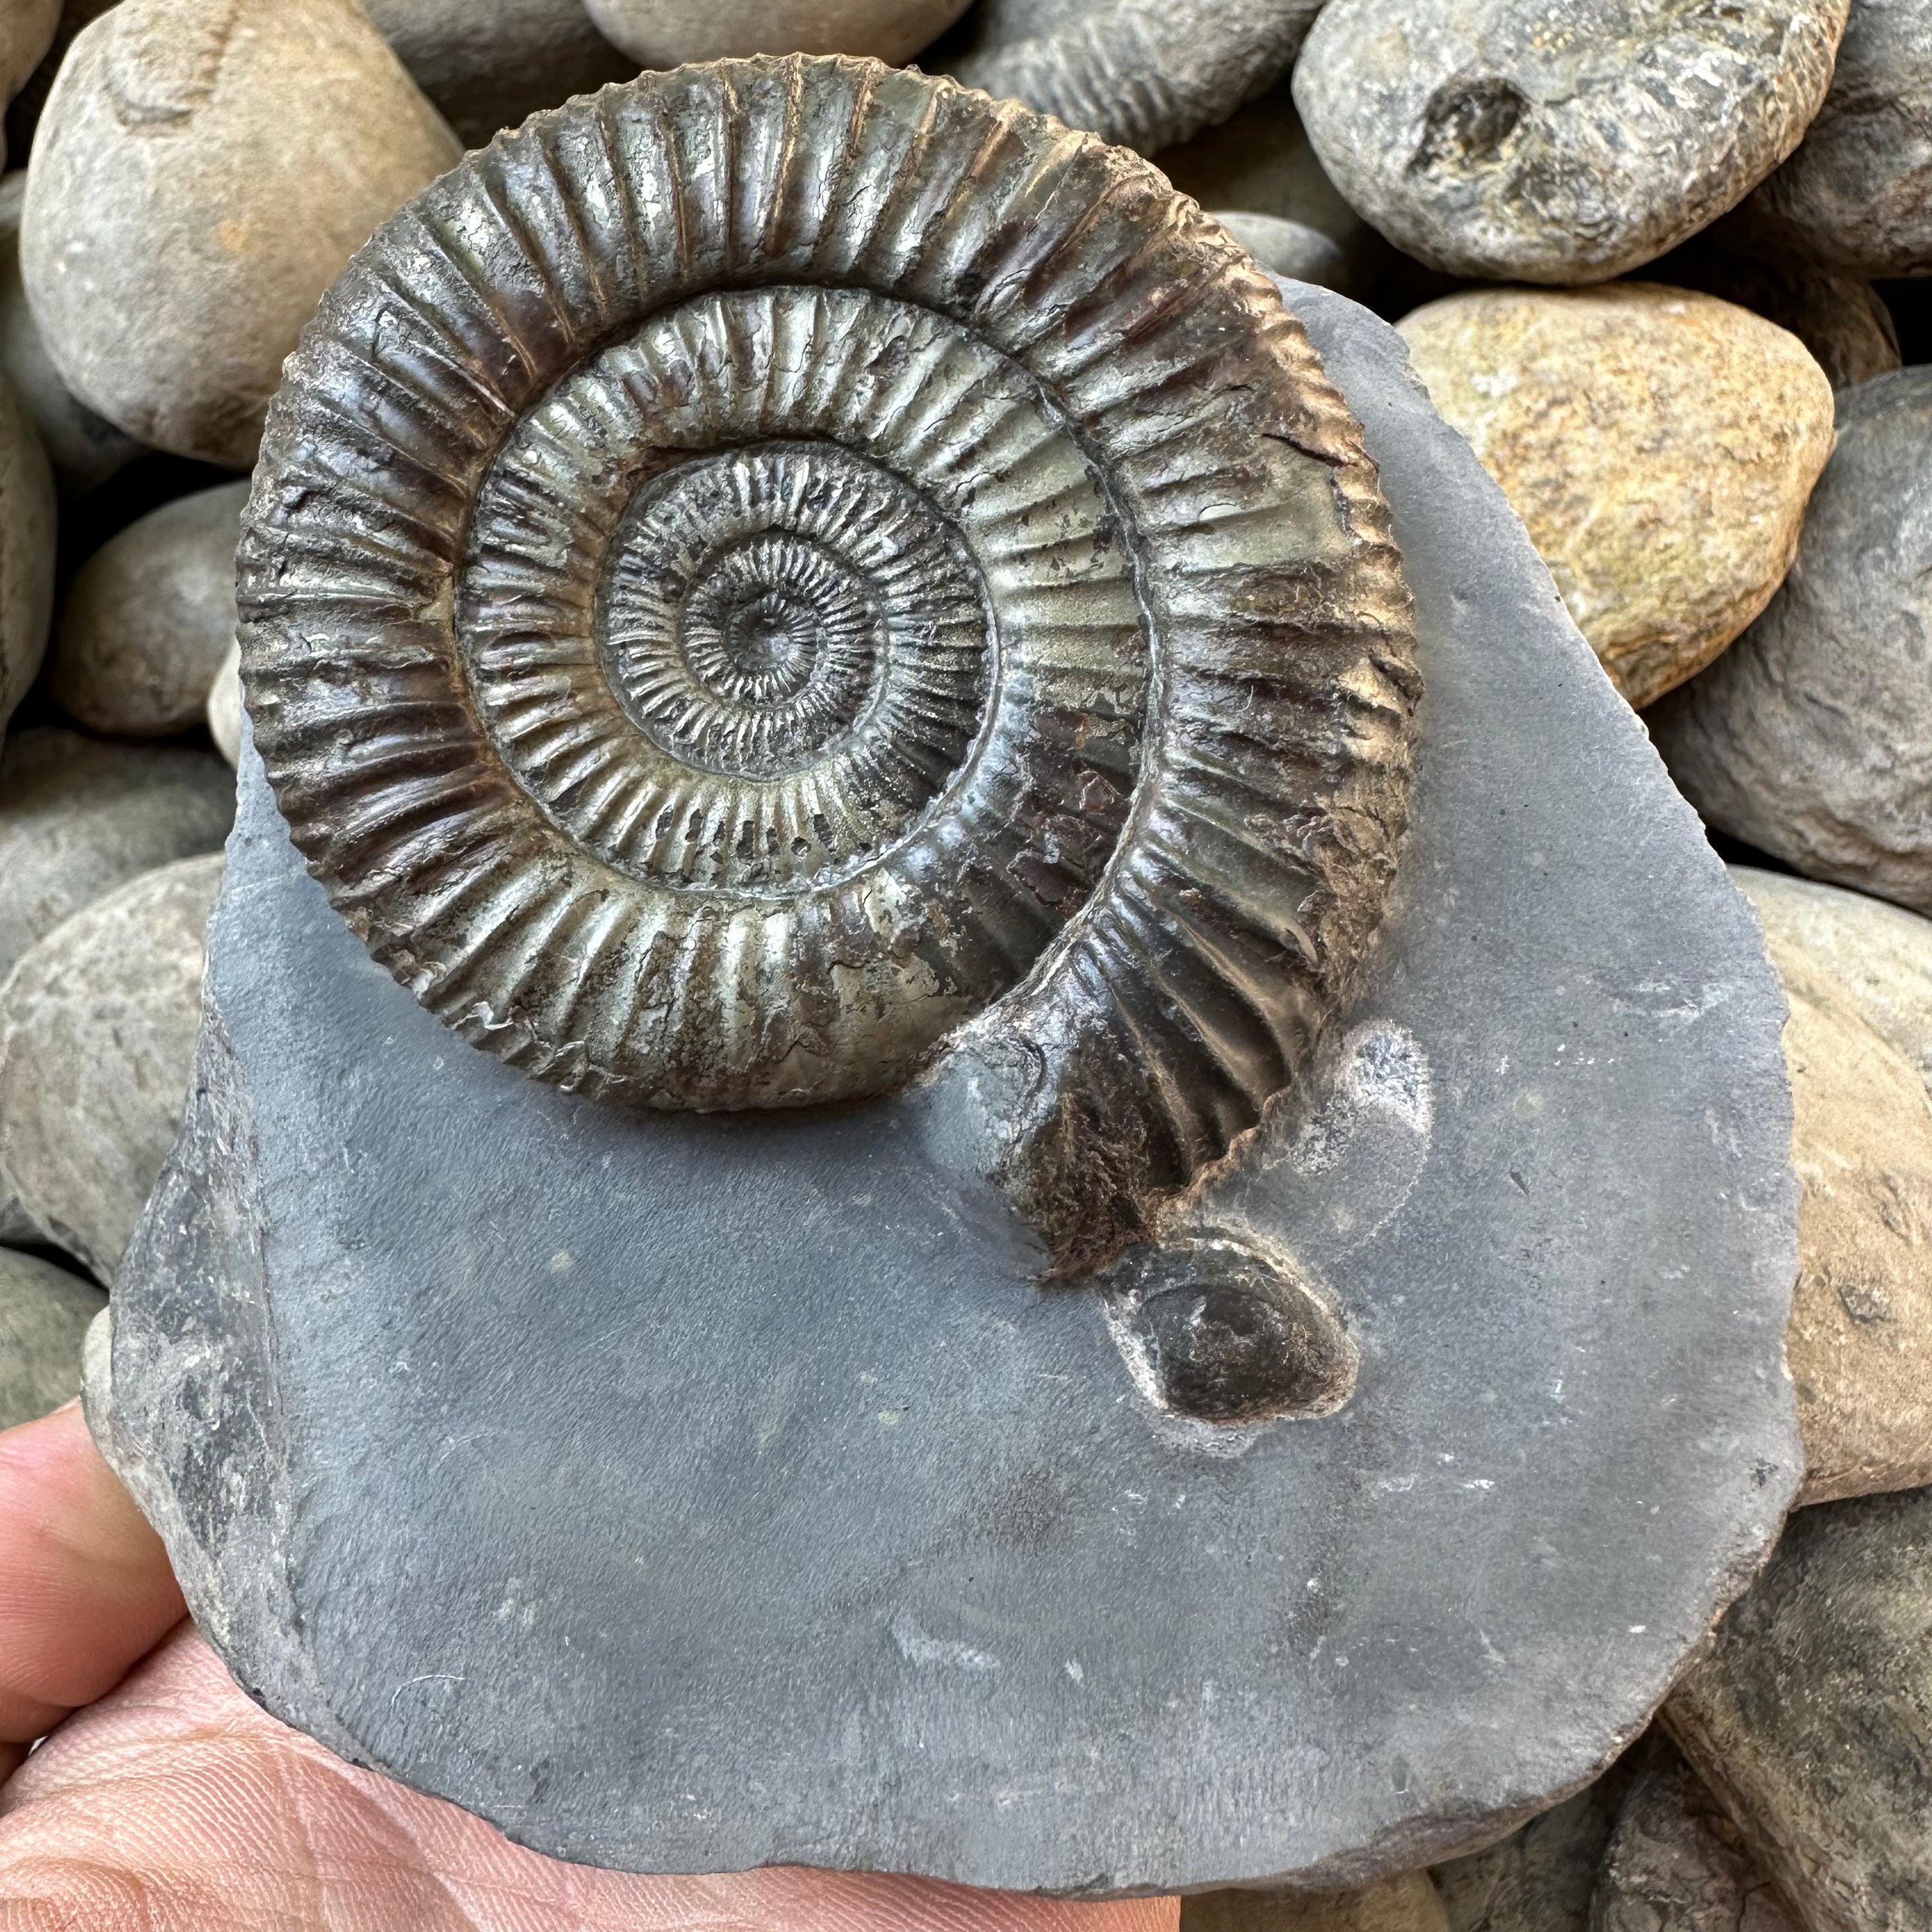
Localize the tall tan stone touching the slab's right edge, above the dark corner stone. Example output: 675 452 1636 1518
1764 923 1932 1503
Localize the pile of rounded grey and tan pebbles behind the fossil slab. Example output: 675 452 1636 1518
0 0 1932 1932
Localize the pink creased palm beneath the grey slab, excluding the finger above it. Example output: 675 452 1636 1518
0 1629 1179 1932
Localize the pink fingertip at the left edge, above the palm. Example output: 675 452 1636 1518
0 1402 185 1775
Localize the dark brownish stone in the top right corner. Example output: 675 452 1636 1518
1743 0 1932 278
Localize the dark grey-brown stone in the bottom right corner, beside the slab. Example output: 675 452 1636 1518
1664 1490 1932 1932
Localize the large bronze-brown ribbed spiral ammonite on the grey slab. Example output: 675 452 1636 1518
240 58 1416 1269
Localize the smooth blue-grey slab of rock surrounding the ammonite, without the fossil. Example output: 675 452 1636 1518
102 286 1798 1896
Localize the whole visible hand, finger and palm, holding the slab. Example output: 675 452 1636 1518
0 1406 1179 1932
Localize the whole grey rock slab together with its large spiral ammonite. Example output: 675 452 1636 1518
89 58 1795 1896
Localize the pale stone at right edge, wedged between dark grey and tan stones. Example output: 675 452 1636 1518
1731 866 1932 1092
